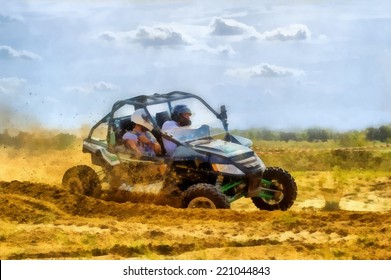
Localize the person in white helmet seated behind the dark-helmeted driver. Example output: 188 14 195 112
122 109 162 156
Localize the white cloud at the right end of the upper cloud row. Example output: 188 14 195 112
261 24 311 41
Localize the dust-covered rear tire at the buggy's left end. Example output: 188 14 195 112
62 165 102 198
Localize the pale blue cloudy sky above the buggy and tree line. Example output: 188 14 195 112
0 0 391 131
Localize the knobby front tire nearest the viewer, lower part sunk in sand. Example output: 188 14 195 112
182 184 230 209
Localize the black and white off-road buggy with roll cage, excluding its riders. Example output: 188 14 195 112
63 91 297 210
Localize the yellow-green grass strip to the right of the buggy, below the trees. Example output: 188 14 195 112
253 141 391 171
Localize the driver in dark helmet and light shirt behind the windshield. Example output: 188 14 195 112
162 105 192 156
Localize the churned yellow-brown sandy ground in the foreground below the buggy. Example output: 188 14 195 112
0 181 391 259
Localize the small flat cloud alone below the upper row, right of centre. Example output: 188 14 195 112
226 63 305 79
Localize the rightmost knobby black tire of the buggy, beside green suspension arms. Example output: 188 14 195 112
251 167 297 211
